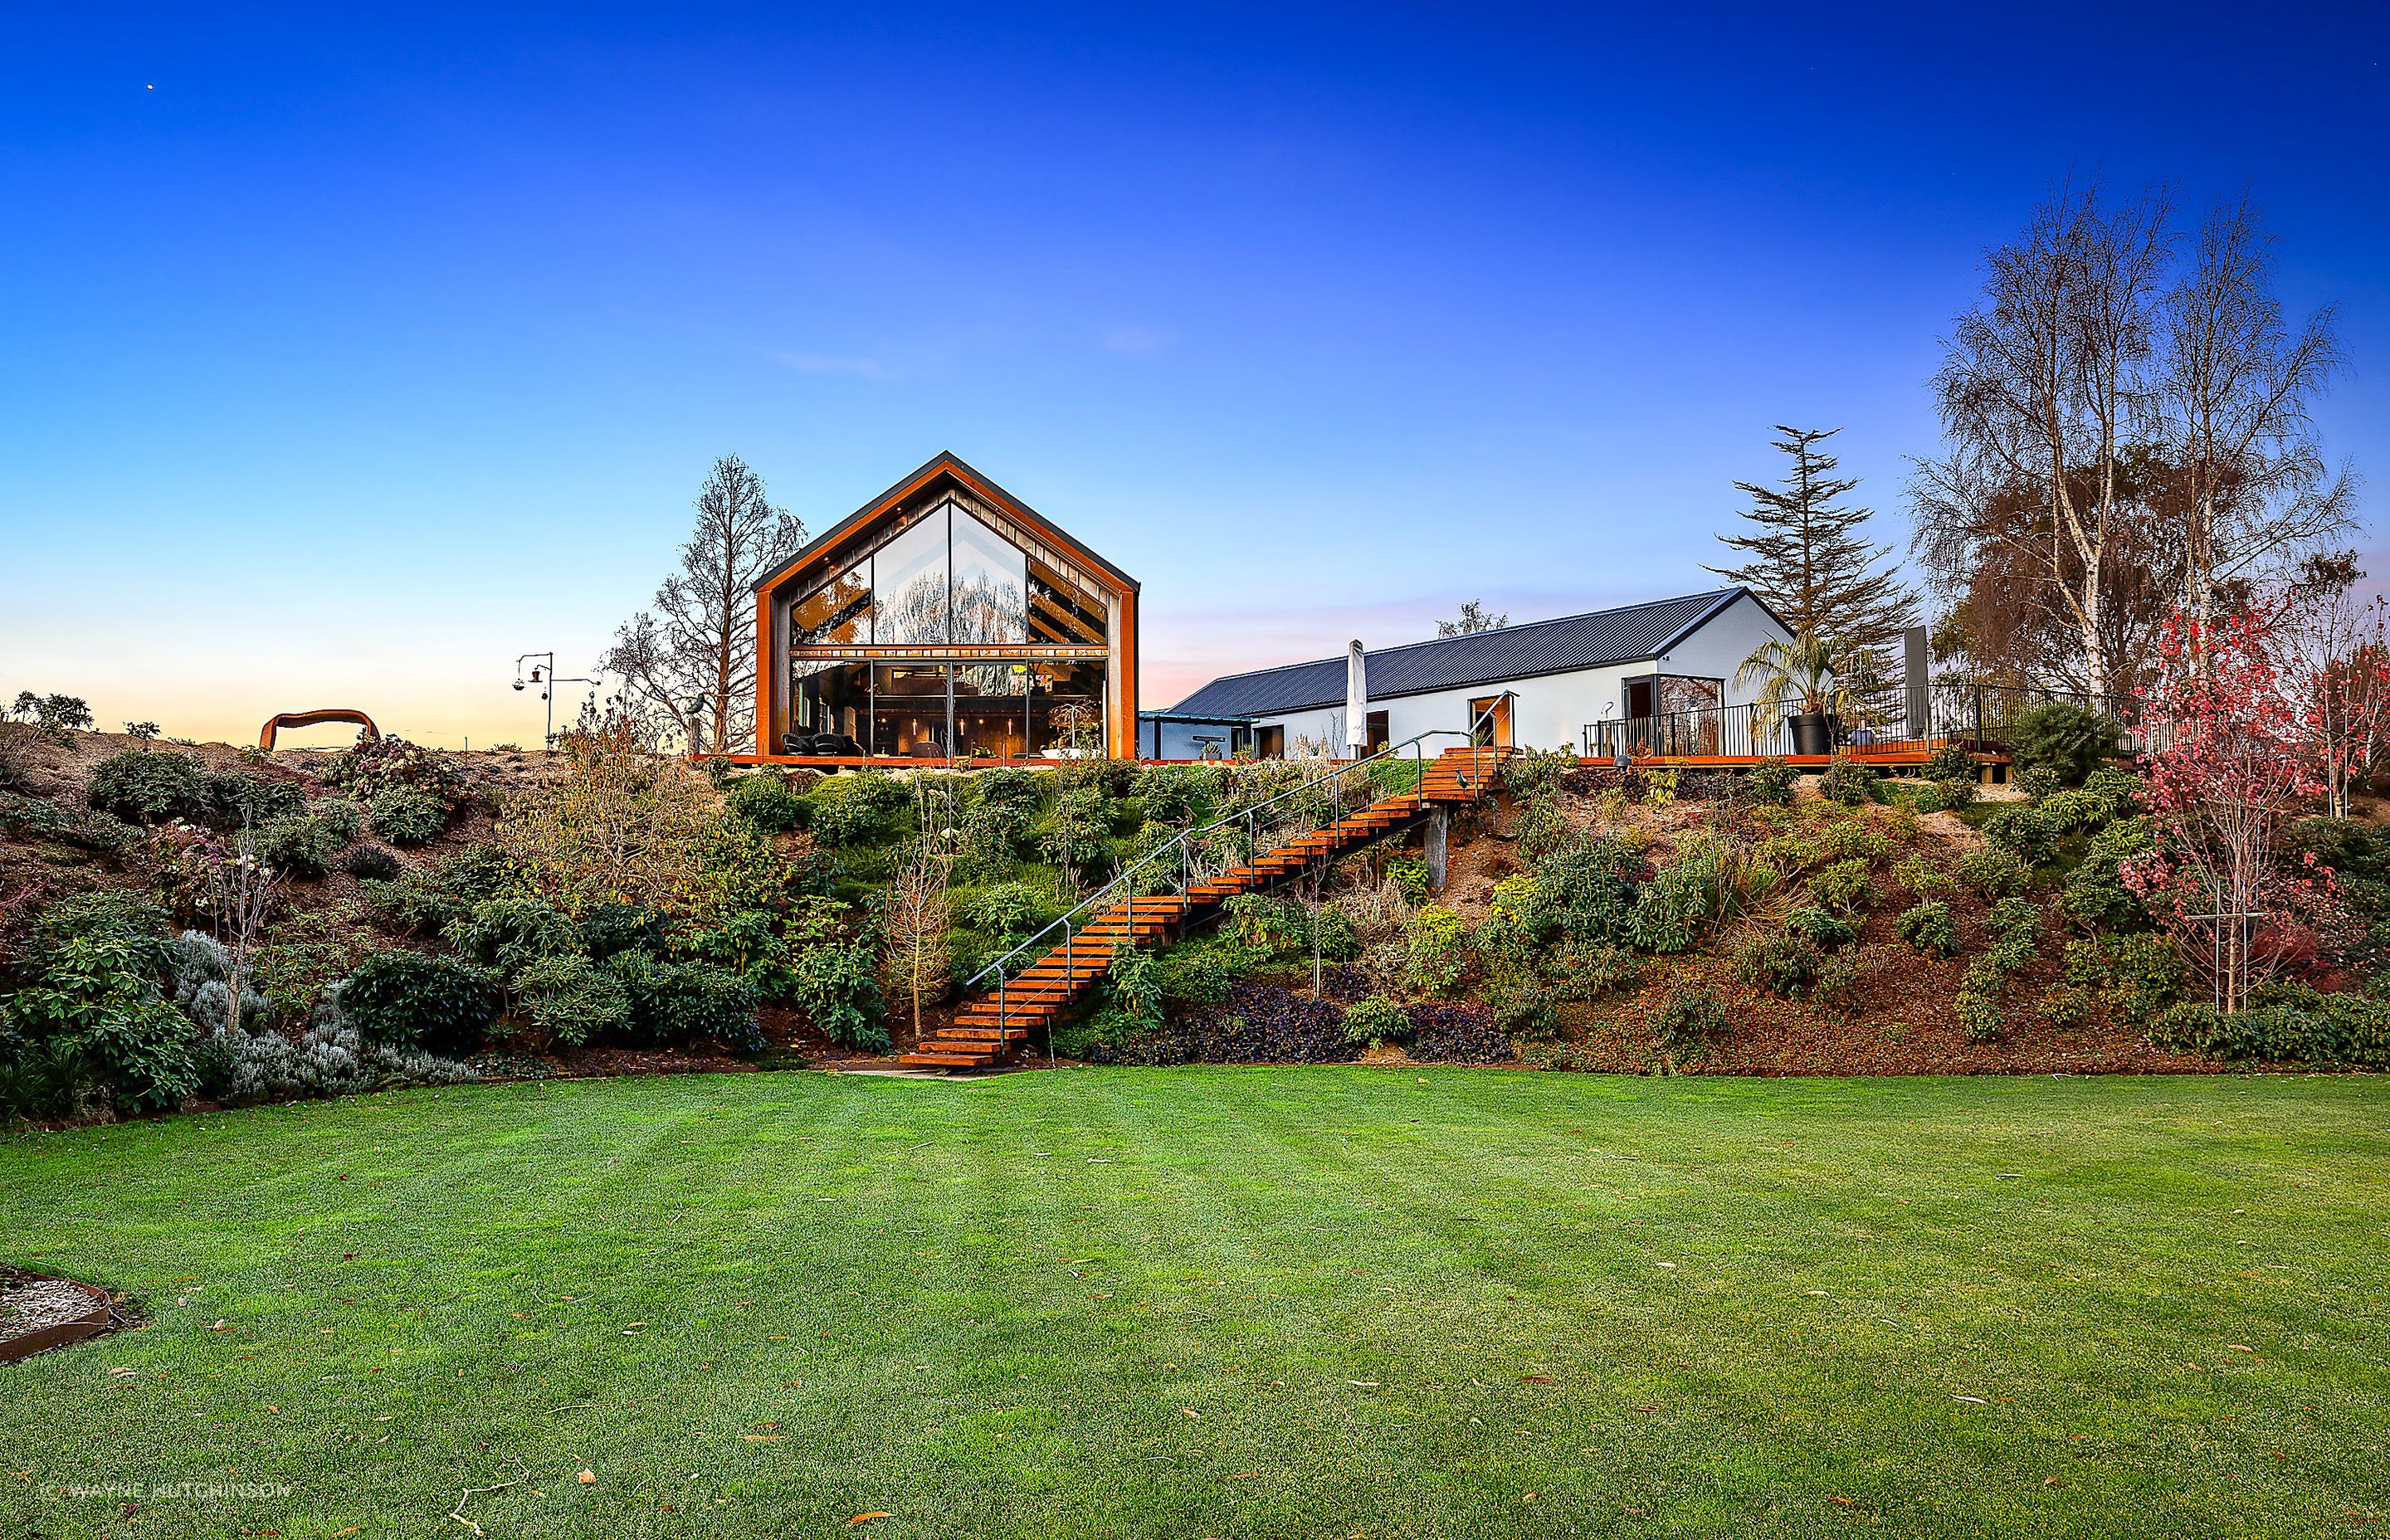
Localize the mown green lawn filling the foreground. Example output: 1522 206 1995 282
0 1069 2390 1540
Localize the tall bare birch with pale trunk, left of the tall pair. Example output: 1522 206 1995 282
1912 187 2173 694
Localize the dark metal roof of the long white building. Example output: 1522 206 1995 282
1171 588 1749 718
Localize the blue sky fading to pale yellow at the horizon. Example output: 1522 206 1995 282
0 5 2390 743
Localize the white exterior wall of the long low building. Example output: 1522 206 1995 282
1255 596 1790 753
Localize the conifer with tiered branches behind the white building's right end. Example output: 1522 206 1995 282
1709 423 1917 651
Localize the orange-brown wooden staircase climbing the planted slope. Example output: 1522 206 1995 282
899 748 1513 1071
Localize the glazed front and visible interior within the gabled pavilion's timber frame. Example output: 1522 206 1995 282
784 497 1109 758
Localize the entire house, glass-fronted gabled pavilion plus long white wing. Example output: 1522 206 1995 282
755 455 1924 763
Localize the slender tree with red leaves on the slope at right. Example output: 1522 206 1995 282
2122 615 2330 1011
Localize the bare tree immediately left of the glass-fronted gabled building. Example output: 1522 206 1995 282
600 455 806 753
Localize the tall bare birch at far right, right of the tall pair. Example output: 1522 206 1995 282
2158 198 2354 631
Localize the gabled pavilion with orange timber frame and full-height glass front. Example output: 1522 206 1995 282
755 455 1138 760
